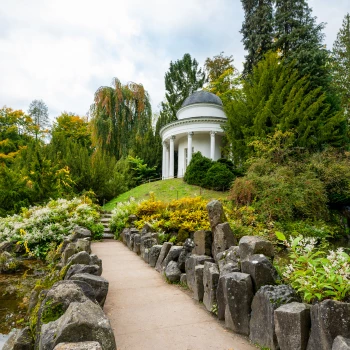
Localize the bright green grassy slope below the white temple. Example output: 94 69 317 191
103 179 227 210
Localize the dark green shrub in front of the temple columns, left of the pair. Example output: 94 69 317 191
184 152 213 186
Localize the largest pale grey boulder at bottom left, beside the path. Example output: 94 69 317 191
39 300 116 350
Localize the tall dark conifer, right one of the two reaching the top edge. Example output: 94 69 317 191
275 0 330 90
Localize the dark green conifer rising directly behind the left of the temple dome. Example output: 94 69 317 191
162 53 205 120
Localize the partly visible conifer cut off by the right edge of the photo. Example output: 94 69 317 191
331 13 350 112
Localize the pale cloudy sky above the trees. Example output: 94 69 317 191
0 0 350 119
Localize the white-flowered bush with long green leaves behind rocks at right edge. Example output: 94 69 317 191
277 233 350 302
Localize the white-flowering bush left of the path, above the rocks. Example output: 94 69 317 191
0 197 103 258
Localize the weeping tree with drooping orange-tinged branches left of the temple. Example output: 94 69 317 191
90 78 152 160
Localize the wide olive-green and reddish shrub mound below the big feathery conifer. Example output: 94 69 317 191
230 161 329 221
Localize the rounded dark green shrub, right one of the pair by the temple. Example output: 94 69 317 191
203 162 234 191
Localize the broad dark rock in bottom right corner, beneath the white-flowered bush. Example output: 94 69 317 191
307 300 350 350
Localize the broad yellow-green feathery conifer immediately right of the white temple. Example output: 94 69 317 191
226 52 346 164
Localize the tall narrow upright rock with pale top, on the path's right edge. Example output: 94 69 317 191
224 272 254 335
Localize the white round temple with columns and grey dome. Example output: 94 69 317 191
160 90 227 179
